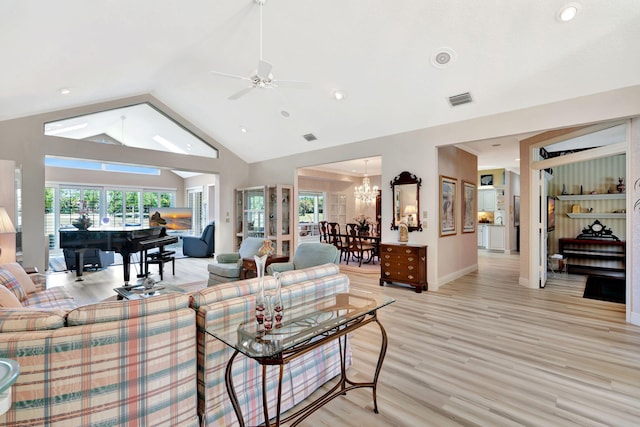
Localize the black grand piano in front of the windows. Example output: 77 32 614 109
60 227 178 284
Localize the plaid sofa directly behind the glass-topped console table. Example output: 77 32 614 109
191 264 351 426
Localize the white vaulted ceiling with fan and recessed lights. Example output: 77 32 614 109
0 0 640 171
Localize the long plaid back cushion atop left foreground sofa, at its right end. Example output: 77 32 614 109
67 293 189 326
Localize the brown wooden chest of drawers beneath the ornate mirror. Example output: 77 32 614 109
380 243 429 293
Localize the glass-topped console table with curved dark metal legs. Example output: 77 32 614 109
206 291 395 426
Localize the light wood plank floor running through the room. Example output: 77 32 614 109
49 251 640 427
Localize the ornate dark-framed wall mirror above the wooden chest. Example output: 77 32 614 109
390 171 422 231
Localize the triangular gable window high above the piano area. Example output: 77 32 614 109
44 102 218 158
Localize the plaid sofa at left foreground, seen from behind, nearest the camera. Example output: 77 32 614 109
0 282 199 427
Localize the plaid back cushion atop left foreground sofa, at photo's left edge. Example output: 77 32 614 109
0 308 66 332
